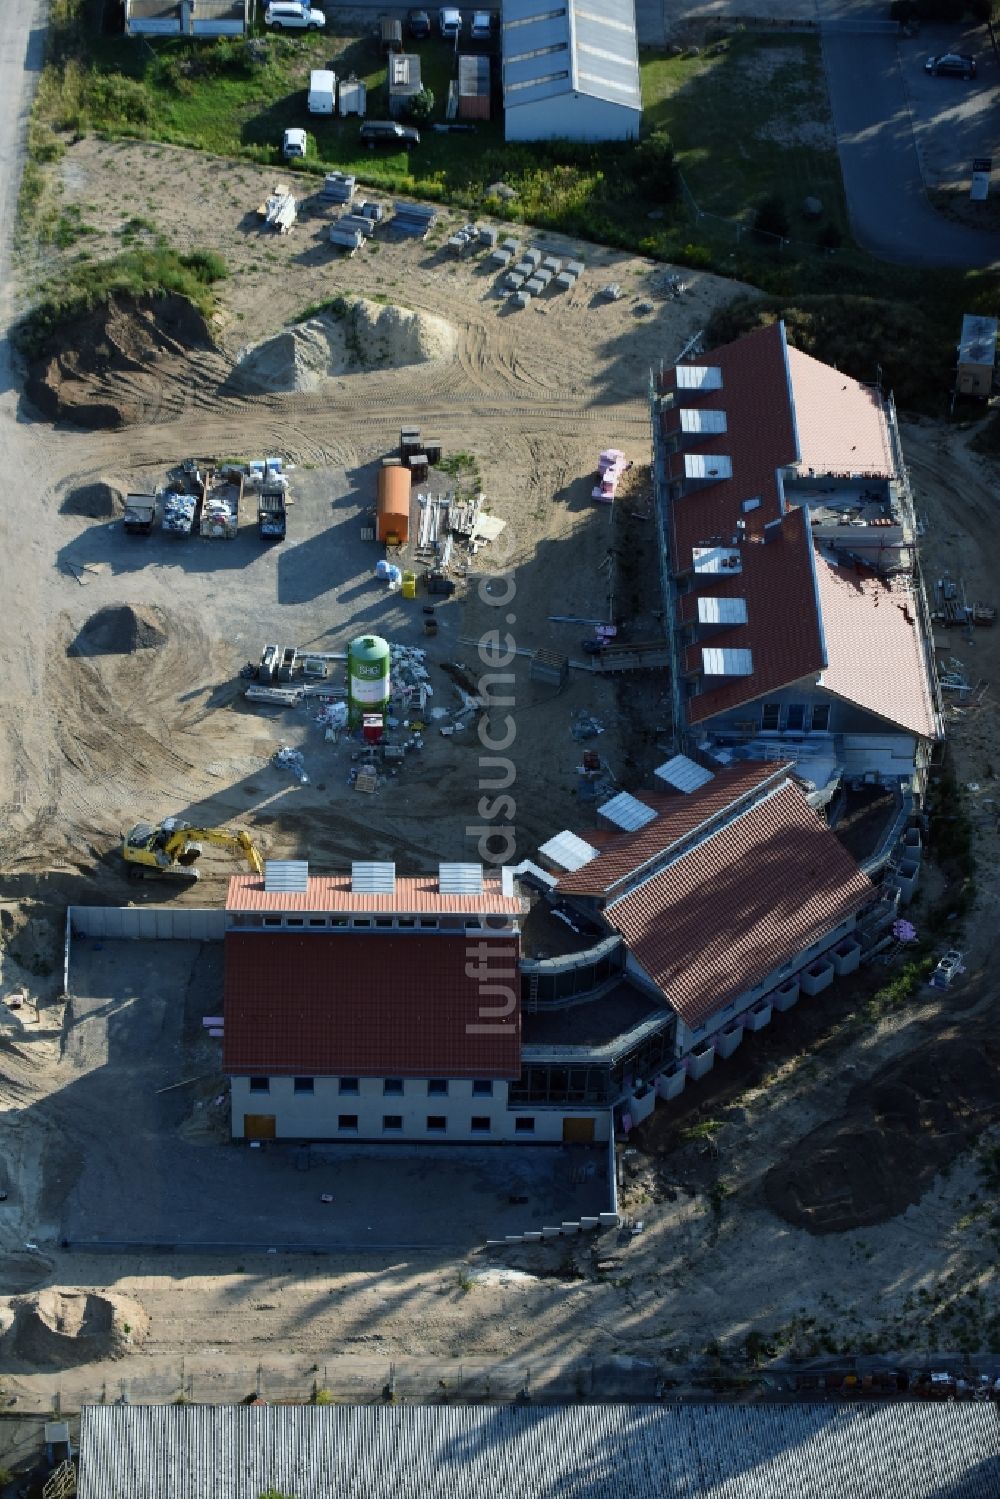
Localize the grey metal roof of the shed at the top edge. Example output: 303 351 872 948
501 0 642 109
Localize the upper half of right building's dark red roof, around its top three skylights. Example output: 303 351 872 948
661 322 798 571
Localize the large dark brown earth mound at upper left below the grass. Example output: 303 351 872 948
27 297 211 427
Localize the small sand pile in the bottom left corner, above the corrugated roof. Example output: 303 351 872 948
3 1286 150 1367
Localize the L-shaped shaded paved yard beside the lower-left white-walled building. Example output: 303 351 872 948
52 938 607 1252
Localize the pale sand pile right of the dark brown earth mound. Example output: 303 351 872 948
232 300 457 393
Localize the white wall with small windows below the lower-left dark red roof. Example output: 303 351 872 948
231 1078 609 1145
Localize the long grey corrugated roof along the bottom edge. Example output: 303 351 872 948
78 1400 1000 1499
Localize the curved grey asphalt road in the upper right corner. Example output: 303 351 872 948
823 10 1000 265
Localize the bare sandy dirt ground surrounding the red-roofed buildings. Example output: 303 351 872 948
0 128 1000 1402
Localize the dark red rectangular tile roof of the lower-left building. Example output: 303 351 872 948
222 932 520 1078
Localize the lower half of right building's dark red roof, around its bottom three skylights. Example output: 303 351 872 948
679 510 826 724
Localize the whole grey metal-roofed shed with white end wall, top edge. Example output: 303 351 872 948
501 0 642 141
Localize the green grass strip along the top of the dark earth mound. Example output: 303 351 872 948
18 244 226 354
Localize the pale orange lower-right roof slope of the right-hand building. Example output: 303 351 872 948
816 553 940 739
